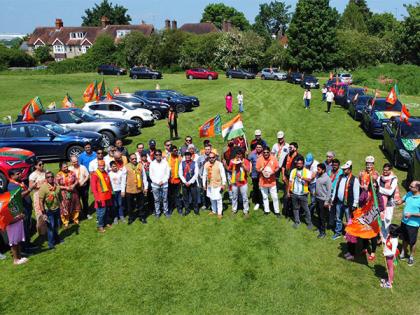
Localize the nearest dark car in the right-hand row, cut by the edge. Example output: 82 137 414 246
382 117 420 169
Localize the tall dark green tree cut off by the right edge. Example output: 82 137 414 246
396 2 420 65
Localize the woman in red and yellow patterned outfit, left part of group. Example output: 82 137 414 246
55 162 80 229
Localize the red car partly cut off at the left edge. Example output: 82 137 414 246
0 147 36 192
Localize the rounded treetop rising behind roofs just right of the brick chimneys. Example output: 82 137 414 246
201 3 250 30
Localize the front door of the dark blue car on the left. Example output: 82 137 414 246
26 124 61 158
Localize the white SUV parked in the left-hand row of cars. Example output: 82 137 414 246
83 100 156 127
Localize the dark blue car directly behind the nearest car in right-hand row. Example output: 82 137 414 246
361 98 402 137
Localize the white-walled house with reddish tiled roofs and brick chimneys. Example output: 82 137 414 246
27 16 154 61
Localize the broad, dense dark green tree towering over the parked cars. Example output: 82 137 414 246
287 0 338 71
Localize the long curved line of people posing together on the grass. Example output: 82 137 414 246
1 130 420 287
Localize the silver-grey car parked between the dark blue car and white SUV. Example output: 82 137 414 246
17 108 135 147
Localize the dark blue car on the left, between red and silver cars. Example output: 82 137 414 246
0 121 102 160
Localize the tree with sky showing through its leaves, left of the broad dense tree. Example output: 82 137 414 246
253 1 290 37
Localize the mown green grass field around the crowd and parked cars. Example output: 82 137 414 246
0 74 420 314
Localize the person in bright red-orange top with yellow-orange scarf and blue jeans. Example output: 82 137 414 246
90 160 112 233
